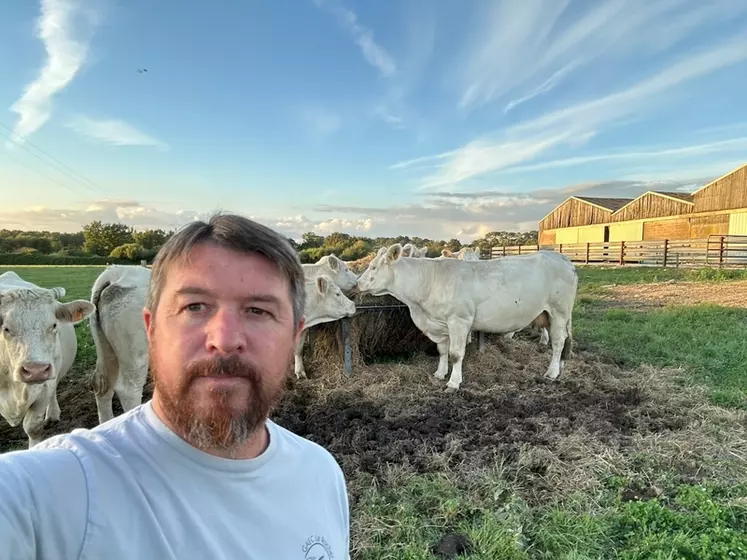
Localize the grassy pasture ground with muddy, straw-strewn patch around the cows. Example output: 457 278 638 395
0 266 747 560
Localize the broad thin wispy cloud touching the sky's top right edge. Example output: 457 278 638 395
457 0 747 109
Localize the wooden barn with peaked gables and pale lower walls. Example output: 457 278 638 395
539 164 747 245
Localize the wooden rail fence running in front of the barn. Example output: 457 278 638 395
489 235 747 267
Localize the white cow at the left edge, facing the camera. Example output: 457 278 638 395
0 272 94 447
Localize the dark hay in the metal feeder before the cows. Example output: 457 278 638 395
303 294 438 377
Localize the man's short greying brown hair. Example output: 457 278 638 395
146 212 306 326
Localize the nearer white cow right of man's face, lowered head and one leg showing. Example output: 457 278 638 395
294 275 355 378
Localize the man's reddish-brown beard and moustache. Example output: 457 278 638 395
150 349 284 454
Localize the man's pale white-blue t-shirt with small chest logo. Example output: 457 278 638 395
0 401 350 560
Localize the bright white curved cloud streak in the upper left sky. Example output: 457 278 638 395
10 0 99 147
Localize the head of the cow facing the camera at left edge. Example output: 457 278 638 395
0 288 95 383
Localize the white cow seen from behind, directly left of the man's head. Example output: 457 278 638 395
88 265 151 423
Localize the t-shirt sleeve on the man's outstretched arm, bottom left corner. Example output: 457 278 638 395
0 449 88 560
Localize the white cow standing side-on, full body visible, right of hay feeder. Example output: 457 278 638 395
358 244 578 392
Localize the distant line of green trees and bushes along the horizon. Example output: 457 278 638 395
0 220 537 264
